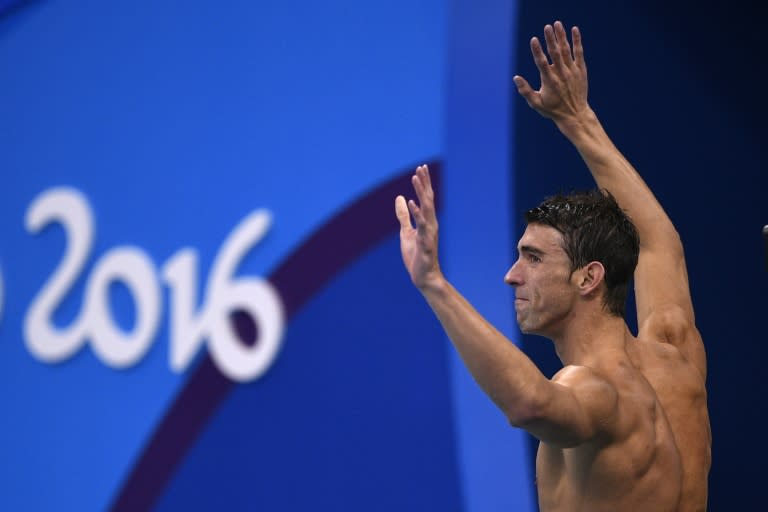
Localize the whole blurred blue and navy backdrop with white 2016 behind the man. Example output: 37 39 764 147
0 0 768 512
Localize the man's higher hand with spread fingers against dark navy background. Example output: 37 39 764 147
513 21 589 123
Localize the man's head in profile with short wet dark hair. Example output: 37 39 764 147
506 190 640 332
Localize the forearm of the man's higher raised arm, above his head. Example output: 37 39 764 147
556 108 677 247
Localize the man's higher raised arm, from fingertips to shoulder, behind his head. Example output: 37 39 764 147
514 22 706 375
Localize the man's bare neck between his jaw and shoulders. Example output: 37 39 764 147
552 309 631 366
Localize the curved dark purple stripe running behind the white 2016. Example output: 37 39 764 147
111 161 440 511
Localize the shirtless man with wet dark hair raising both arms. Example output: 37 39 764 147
395 22 711 512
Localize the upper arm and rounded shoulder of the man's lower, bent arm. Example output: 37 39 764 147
516 366 618 448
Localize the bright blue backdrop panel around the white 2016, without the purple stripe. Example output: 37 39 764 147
0 1 531 510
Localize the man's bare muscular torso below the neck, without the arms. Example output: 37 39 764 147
536 340 710 512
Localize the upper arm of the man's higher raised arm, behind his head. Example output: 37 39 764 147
635 230 706 376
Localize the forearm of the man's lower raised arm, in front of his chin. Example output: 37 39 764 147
421 278 550 426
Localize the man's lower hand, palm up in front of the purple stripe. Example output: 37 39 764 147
395 165 442 289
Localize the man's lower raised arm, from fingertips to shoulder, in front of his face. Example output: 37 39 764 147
395 165 617 447
